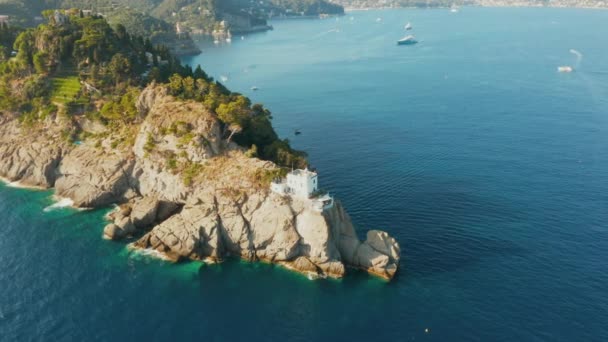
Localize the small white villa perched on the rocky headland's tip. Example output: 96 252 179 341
270 168 334 212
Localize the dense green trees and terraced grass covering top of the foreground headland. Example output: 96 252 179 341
0 10 306 166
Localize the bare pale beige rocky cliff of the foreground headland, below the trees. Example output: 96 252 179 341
0 86 400 279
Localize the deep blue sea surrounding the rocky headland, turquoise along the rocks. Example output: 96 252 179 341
0 8 608 342
